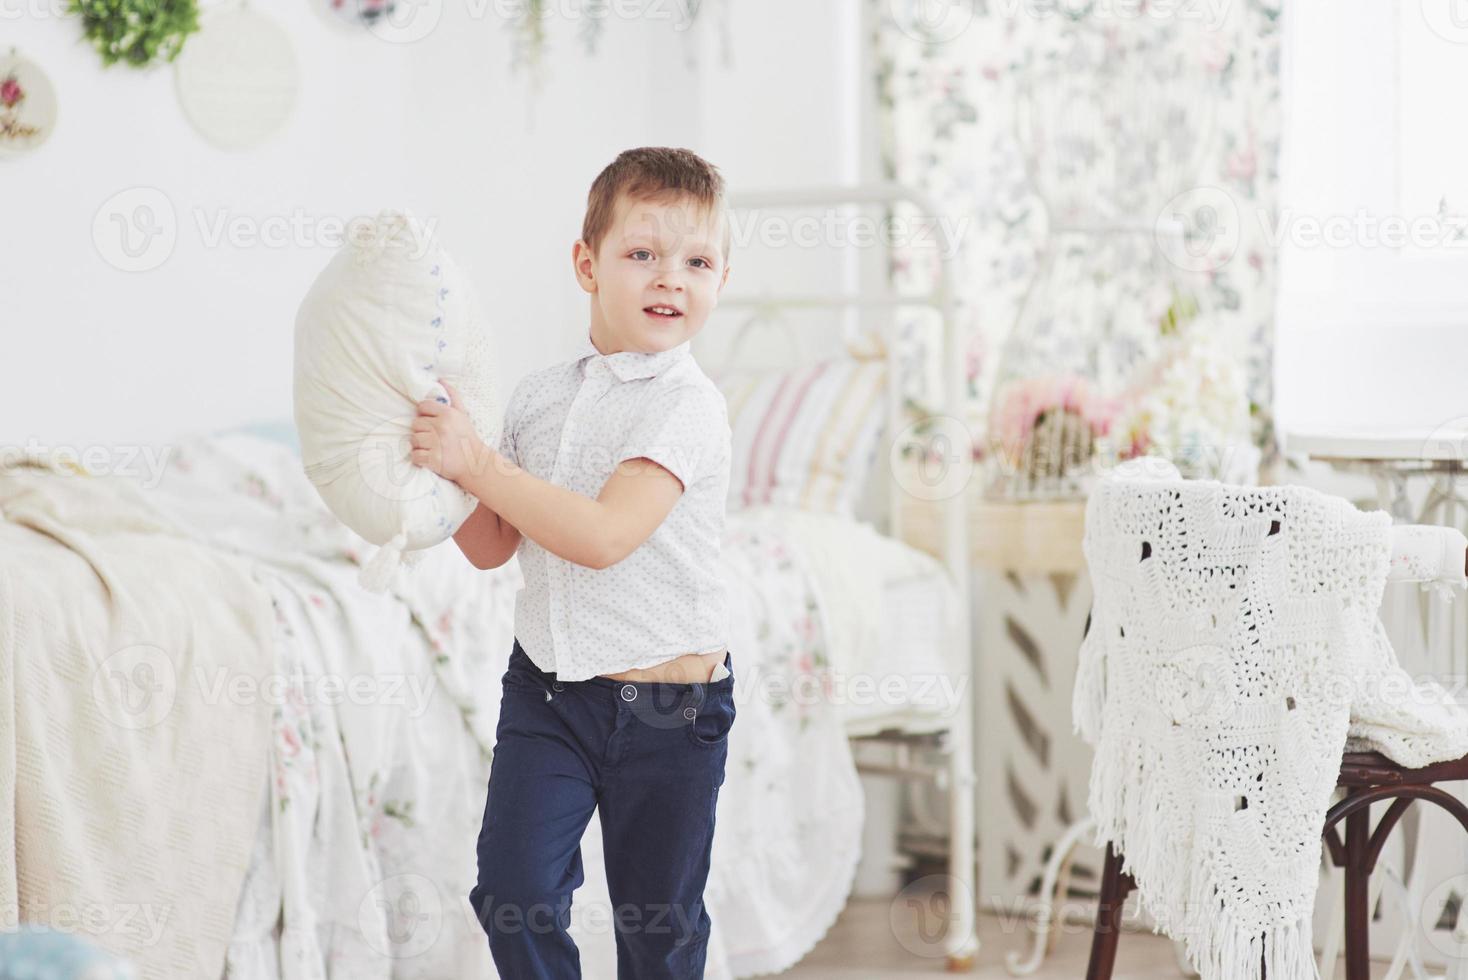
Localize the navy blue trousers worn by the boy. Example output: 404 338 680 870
470 640 734 980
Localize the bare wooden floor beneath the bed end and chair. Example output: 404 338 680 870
778 899 1387 980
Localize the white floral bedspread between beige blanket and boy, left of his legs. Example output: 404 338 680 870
143 436 520 980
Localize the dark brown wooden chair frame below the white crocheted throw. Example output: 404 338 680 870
1086 753 1468 980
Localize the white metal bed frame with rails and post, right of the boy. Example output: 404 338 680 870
719 183 979 971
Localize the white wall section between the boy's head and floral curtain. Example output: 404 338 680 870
684 0 885 369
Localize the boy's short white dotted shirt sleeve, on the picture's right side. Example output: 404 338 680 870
617 384 728 490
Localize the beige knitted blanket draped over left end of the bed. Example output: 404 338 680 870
0 465 273 979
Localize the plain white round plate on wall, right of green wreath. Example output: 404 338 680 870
175 4 301 150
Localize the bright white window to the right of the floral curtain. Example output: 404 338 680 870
1260 0 1468 431
